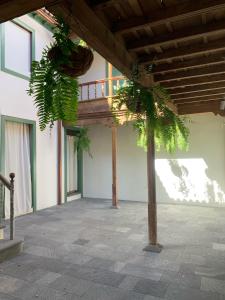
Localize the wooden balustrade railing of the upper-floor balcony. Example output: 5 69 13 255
79 76 127 101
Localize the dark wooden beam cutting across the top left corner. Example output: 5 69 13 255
0 0 60 23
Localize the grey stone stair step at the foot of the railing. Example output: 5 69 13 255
0 239 23 262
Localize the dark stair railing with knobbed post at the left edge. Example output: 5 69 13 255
0 173 15 240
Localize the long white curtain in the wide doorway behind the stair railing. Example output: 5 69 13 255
5 122 32 217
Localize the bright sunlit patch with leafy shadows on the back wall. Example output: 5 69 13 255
156 158 225 205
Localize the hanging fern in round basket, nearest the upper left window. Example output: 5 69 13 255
28 18 93 130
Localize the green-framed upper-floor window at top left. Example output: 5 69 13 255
1 21 34 79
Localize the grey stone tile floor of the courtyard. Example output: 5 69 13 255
0 199 225 300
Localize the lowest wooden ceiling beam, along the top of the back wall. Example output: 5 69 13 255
178 100 223 115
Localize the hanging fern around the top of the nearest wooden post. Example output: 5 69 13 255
112 81 189 152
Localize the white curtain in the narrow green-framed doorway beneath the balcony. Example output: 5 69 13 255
67 135 77 192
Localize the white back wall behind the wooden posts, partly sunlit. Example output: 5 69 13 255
84 113 225 206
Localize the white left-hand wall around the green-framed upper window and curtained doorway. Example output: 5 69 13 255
0 16 57 209
